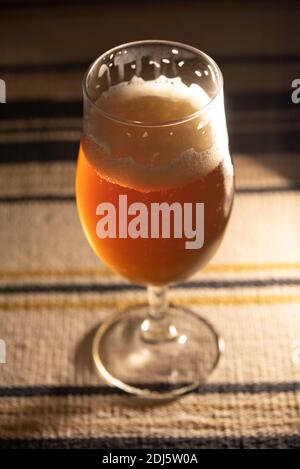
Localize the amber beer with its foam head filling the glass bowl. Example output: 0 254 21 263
76 78 233 285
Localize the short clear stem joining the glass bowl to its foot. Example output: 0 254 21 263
141 286 178 343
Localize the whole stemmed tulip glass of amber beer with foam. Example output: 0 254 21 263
76 40 234 399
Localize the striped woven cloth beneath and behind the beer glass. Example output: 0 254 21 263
0 2 300 448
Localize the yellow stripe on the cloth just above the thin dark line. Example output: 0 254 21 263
0 262 300 280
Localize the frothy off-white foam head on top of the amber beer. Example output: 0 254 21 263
83 76 231 192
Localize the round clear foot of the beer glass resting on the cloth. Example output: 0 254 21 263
93 305 224 400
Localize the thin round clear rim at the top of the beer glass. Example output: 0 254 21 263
82 39 224 127
